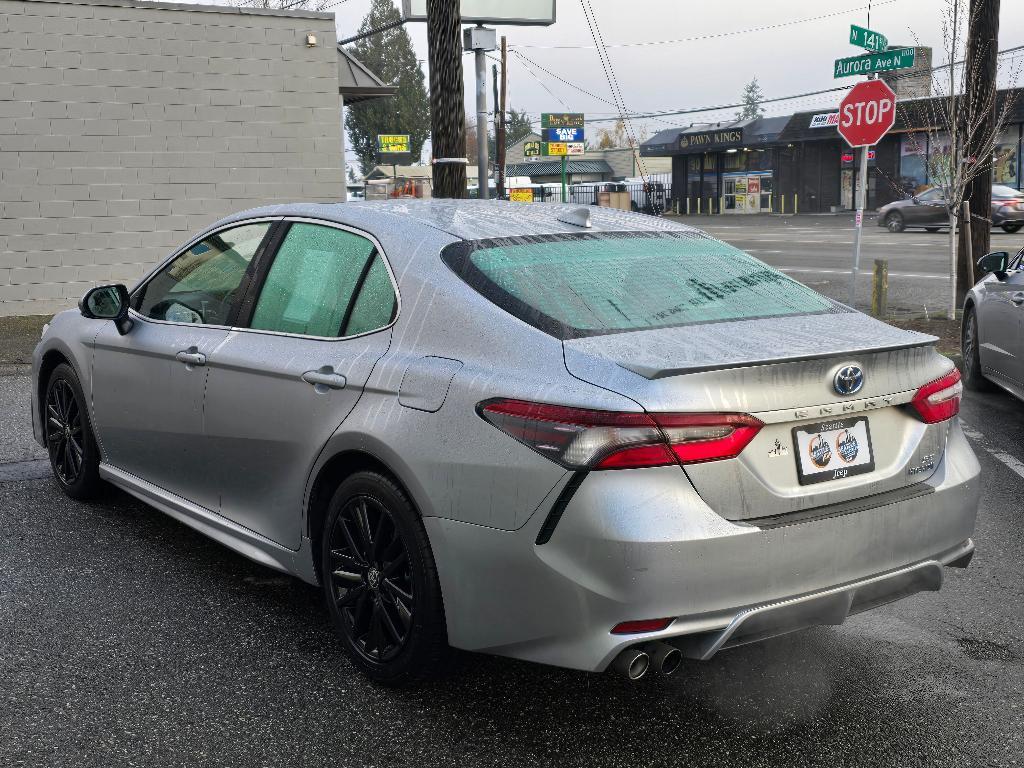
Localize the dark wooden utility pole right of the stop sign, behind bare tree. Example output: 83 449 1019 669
954 0 999 306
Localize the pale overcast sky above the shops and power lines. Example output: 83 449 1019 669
332 0 1024 163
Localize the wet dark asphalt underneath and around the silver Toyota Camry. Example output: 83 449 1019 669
0 374 1024 768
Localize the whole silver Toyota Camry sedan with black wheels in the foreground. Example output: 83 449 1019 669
33 201 979 684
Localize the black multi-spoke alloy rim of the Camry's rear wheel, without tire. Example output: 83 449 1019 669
330 496 416 664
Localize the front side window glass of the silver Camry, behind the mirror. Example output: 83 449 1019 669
133 221 270 326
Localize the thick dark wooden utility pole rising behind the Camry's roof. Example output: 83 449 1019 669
427 0 467 198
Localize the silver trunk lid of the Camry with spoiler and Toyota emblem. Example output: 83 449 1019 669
563 311 950 520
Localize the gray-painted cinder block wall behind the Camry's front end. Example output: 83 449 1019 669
0 0 345 315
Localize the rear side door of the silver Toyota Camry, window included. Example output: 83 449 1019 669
198 220 398 550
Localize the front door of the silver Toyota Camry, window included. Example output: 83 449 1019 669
92 220 272 509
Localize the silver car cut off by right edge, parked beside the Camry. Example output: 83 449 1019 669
961 249 1024 398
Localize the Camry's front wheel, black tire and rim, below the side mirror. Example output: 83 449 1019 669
40 362 103 501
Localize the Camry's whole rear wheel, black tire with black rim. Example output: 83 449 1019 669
321 471 453 687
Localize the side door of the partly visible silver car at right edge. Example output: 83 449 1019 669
978 254 1024 386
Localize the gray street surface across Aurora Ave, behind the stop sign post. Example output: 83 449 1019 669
675 214 1024 314
